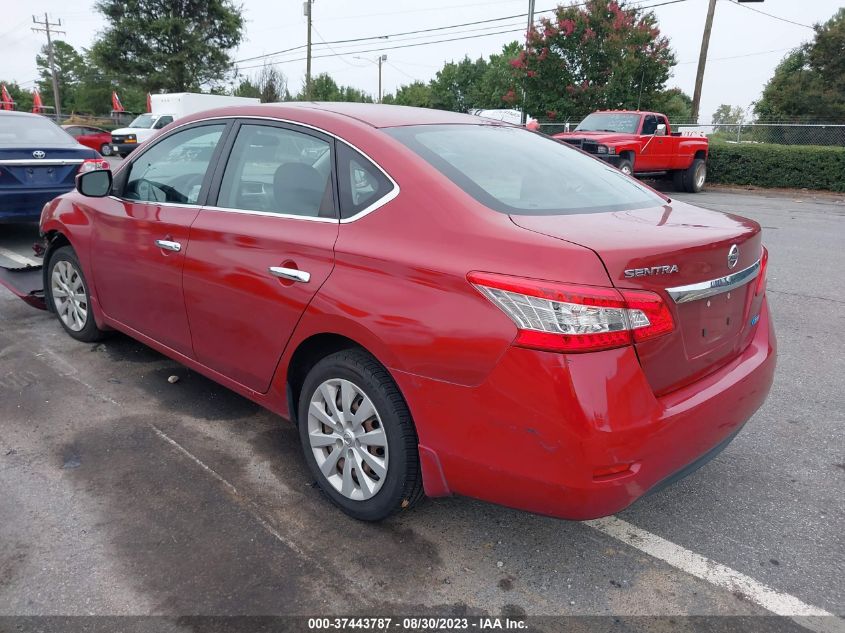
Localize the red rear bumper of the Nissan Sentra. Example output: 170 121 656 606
394 296 776 520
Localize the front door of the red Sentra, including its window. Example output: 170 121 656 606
91 121 227 356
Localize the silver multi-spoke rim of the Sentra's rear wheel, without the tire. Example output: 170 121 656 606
308 378 388 501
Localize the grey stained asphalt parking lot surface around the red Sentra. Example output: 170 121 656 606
0 183 845 631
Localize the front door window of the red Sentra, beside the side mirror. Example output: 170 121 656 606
123 123 226 204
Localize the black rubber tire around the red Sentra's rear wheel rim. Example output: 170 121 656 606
297 349 424 521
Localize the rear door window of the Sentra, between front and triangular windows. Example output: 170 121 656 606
217 124 337 218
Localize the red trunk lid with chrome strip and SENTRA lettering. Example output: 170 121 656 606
511 201 762 395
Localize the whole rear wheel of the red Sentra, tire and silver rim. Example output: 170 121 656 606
298 349 423 521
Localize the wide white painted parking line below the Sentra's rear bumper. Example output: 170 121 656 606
584 517 845 633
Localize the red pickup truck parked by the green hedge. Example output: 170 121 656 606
554 110 708 193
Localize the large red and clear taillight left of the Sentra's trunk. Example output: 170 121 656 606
467 272 674 352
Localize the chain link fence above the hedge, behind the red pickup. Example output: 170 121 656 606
539 116 845 147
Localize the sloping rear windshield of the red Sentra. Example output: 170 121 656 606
385 125 665 215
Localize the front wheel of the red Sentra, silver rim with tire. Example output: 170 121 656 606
47 246 105 342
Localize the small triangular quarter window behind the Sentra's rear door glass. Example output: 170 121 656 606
337 142 395 219
